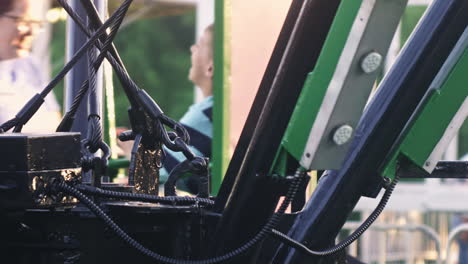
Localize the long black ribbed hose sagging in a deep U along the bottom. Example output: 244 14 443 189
57 168 306 264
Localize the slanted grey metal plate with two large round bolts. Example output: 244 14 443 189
301 0 407 169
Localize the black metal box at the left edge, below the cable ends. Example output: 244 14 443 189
0 133 81 210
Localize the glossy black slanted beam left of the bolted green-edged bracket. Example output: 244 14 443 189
213 0 340 262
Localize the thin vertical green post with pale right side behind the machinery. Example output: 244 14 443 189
211 0 231 195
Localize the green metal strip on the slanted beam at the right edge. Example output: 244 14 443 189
381 31 468 178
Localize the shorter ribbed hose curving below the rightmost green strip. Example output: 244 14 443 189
270 175 400 256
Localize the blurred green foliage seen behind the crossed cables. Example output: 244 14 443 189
51 13 195 127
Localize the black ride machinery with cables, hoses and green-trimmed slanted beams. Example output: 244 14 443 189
0 0 468 264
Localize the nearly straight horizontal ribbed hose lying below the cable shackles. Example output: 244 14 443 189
76 185 214 205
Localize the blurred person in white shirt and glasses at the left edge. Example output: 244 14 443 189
0 0 60 133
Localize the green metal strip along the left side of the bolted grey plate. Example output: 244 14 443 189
271 0 362 176
